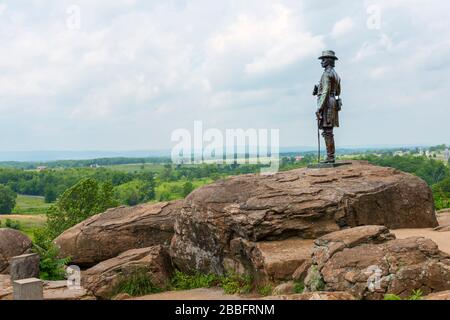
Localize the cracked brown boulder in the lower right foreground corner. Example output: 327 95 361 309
305 226 450 300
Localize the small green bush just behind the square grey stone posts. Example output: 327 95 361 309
34 244 70 280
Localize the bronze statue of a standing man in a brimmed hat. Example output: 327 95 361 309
313 50 342 163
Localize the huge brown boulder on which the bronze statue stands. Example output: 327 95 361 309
171 162 437 274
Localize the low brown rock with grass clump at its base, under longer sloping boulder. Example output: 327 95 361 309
82 245 173 299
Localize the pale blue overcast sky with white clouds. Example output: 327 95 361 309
0 0 450 151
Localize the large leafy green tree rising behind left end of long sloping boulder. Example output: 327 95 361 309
46 178 117 239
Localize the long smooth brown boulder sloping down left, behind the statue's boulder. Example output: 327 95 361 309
55 201 181 267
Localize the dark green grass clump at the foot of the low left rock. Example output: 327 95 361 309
111 268 163 297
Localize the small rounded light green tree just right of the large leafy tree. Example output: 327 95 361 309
114 180 155 206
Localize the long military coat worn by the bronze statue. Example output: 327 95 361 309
317 67 341 128
